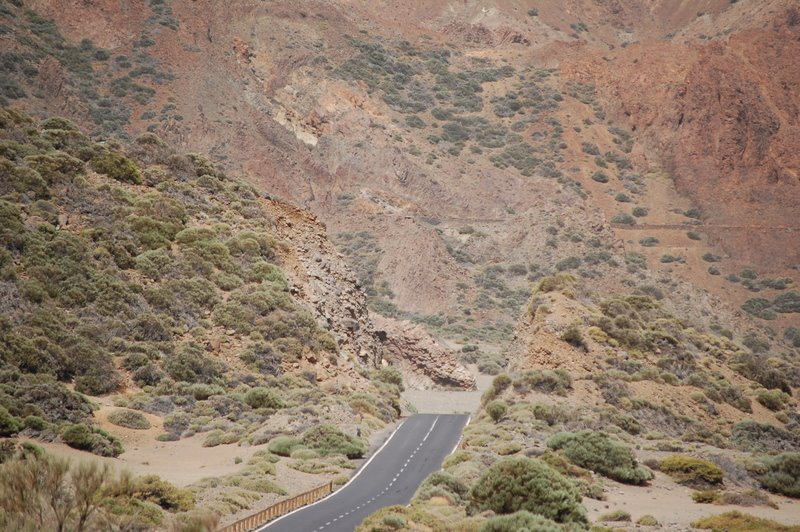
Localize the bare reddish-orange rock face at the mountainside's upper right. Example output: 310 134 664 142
563 3 800 270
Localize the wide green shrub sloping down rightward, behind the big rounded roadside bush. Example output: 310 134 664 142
547 430 653 484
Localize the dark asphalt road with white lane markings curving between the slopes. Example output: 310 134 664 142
258 414 468 532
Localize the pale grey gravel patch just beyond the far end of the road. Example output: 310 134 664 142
402 365 494 416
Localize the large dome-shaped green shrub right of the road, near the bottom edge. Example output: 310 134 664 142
467 457 588 524
